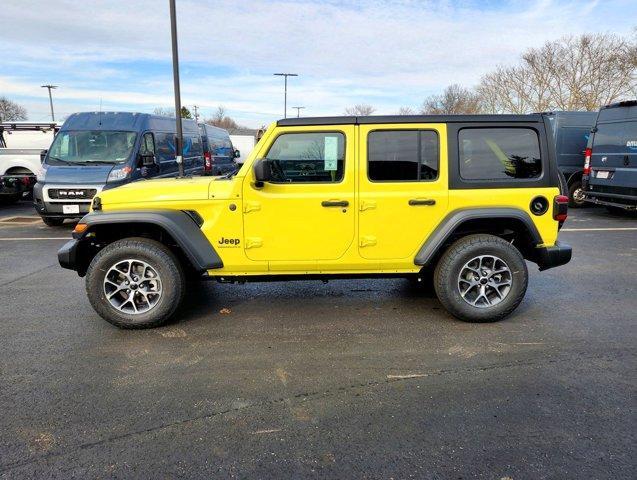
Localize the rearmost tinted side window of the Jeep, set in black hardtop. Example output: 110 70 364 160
458 127 542 180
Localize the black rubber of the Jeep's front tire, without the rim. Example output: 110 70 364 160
86 237 186 329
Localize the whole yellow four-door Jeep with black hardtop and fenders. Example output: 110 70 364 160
58 115 571 328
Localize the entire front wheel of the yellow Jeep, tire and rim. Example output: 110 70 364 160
86 238 185 328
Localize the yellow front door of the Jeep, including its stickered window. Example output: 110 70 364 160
243 125 356 270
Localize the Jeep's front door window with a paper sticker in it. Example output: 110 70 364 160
266 132 345 183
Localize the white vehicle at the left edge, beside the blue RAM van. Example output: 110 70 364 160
0 122 60 203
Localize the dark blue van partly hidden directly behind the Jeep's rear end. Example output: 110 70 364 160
544 112 597 207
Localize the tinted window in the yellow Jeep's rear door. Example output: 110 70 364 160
367 130 438 182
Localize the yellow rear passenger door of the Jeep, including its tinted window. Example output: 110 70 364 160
358 124 448 260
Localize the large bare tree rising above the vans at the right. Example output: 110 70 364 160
477 34 637 113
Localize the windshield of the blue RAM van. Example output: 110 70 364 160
47 130 137 165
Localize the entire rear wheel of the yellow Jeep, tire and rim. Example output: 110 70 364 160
434 234 529 322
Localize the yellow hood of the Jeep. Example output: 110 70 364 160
99 177 212 205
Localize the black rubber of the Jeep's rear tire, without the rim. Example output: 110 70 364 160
434 234 529 322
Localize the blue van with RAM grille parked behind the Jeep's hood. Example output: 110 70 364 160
33 112 204 225
